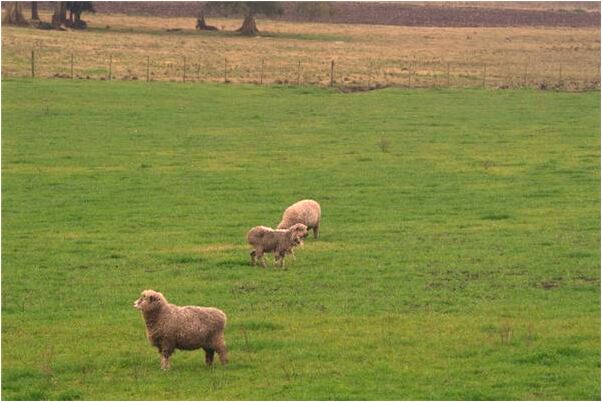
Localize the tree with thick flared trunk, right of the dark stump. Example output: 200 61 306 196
206 1 283 36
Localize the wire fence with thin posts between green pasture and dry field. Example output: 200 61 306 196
2 50 600 91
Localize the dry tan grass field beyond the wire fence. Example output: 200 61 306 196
2 11 600 90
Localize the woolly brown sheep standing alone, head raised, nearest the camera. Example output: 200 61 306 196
134 290 228 370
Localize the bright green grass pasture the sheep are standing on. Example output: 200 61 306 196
2 77 600 400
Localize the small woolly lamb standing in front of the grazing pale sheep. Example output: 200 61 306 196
247 223 307 268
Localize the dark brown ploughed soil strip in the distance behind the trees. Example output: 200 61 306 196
85 2 600 27
